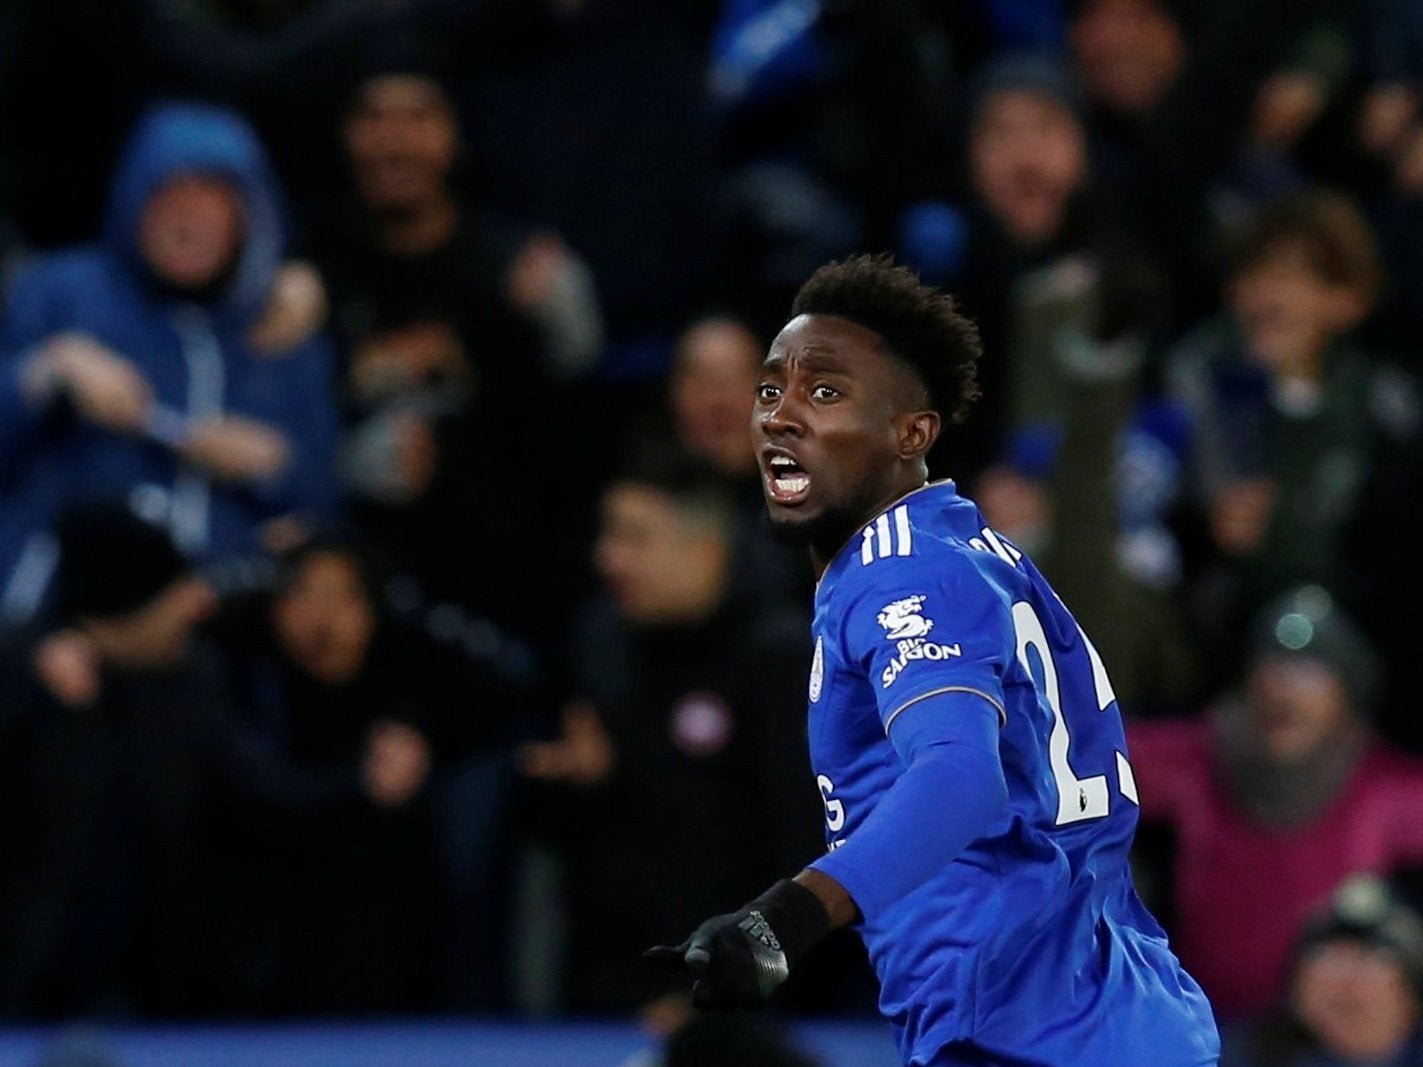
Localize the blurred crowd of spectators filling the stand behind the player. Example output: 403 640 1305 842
0 0 1423 1067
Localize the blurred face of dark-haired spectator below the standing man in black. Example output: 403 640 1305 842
272 552 376 686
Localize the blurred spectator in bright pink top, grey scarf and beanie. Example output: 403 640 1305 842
1127 588 1423 1020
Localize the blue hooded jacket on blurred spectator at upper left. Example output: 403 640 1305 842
0 104 336 619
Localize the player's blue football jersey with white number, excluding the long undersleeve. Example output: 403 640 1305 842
810 482 1220 1067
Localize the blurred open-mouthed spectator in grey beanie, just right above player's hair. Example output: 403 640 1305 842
899 54 1163 484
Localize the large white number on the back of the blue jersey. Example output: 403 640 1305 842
1013 600 1137 827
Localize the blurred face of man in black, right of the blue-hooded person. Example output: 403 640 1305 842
346 74 460 211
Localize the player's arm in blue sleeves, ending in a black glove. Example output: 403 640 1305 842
647 568 1012 1007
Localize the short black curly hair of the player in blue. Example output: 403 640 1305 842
791 255 983 423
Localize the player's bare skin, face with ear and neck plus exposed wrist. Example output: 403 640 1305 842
751 314 942 928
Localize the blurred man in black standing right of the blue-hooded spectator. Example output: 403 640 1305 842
312 62 601 622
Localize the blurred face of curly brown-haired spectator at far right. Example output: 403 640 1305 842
1229 240 1362 373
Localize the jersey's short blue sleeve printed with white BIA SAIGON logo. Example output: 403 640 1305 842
841 553 1015 740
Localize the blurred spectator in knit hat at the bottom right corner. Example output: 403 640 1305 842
1221 876 1423 1067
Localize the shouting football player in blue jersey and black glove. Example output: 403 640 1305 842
647 256 1220 1067
